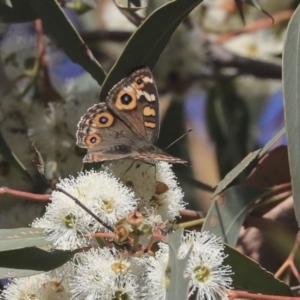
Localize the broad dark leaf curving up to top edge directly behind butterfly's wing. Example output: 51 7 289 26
100 0 202 101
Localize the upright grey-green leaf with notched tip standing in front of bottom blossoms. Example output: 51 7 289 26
167 229 192 300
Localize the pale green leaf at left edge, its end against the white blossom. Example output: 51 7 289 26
0 228 51 252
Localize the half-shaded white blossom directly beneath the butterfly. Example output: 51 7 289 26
105 160 185 222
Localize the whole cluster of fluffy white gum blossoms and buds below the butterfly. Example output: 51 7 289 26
0 160 232 300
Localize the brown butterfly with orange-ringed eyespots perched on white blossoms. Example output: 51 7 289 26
76 67 186 163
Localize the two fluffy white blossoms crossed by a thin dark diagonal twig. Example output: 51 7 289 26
32 171 136 250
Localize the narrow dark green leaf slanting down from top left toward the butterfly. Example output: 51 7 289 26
27 0 106 85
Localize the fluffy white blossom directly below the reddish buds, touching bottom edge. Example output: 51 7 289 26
70 248 139 300
